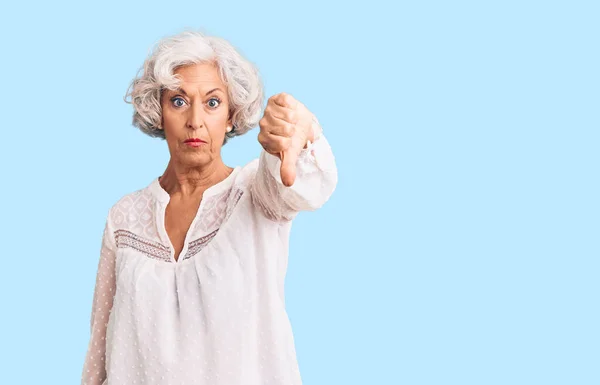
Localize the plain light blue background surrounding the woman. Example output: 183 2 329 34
0 1 600 385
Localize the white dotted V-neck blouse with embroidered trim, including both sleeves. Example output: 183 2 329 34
81 136 337 385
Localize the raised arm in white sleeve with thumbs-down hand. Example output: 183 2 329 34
251 93 337 221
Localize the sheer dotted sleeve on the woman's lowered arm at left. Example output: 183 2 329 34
81 214 116 385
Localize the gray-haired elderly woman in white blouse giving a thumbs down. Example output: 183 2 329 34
81 31 337 385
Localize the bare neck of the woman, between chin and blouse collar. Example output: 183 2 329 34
159 158 233 199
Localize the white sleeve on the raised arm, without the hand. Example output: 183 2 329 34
250 119 337 221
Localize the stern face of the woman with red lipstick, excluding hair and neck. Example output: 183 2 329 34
161 64 231 167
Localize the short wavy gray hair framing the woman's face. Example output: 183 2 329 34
123 30 264 142
